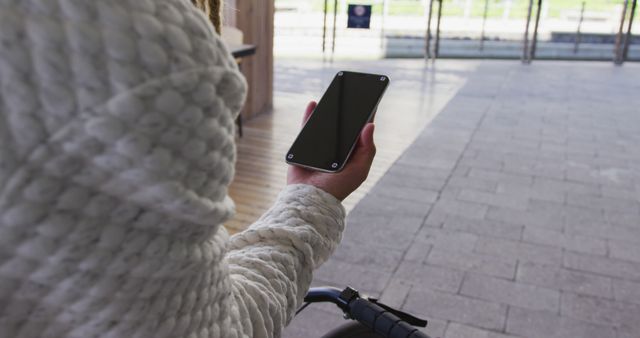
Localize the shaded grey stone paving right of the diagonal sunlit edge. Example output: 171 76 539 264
284 61 640 338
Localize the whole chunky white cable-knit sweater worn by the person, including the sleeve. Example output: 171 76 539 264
0 0 344 338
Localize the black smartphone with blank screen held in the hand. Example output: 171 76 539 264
286 71 389 173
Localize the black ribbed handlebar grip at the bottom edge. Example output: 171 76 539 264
349 298 429 338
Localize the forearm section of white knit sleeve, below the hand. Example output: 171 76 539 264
227 185 345 337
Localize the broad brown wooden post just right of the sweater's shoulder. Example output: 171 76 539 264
236 0 275 119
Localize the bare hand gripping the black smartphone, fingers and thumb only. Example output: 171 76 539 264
287 101 376 201
